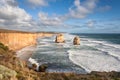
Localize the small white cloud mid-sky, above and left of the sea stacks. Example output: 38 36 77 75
38 12 63 26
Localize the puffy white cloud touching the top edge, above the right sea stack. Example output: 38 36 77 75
69 0 98 18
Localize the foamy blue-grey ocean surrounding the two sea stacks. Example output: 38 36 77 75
31 33 120 74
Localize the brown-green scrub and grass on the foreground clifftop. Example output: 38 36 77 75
0 43 120 80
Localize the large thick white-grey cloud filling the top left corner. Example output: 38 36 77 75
0 0 36 29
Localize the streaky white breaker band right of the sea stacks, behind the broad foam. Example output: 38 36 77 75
81 39 120 59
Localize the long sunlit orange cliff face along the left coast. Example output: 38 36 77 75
0 31 53 50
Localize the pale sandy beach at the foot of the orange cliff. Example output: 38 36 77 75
16 46 36 61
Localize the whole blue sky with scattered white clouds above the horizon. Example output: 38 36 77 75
0 0 120 33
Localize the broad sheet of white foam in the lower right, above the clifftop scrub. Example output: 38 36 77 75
68 50 120 72
